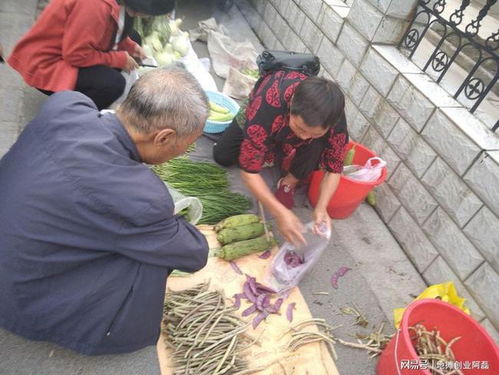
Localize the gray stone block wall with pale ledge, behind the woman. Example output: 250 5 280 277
235 0 499 340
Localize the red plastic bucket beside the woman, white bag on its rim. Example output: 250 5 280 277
308 142 386 219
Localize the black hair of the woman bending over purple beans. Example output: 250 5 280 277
290 77 345 129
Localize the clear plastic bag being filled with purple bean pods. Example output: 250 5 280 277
266 222 331 293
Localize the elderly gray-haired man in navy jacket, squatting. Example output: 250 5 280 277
0 69 208 354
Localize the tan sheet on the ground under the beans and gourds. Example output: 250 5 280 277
157 226 339 375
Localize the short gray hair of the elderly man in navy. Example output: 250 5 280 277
117 67 208 137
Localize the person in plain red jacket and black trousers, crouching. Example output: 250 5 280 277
8 0 175 109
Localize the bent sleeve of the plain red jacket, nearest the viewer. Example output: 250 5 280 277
62 1 127 68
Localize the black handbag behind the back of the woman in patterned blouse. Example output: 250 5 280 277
256 50 321 76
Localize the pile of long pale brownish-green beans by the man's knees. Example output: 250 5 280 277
163 283 259 375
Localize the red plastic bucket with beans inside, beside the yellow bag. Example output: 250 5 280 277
377 299 499 375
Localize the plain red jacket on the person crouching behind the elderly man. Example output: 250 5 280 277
8 0 137 92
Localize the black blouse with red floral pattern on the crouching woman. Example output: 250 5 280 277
239 71 348 173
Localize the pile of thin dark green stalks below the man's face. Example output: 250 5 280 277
152 157 251 224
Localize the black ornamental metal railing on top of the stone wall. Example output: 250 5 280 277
399 0 499 131
